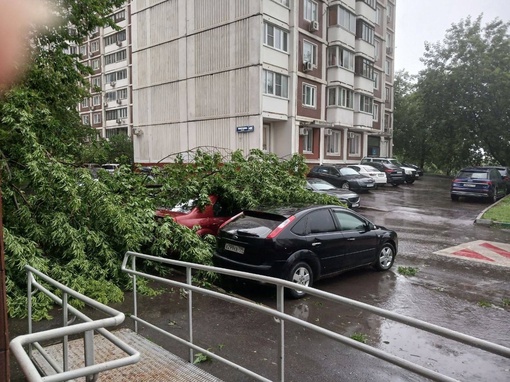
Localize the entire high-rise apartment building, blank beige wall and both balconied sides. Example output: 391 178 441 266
79 0 395 165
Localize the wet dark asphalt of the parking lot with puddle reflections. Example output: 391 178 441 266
10 176 510 382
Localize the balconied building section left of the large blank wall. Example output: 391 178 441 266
75 2 133 138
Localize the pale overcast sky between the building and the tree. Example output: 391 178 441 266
395 0 510 74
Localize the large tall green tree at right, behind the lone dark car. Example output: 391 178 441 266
418 16 510 171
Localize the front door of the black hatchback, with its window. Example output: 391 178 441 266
333 209 379 268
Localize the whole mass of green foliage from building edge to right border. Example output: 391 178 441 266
394 16 510 174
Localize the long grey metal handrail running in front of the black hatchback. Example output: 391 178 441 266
122 252 510 382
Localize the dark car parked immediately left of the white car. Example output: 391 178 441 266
308 165 375 191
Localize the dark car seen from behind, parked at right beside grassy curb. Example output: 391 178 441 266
450 167 507 202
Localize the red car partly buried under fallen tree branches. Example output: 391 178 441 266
155 195 235 236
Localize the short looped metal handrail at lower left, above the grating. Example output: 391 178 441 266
10 265 140 382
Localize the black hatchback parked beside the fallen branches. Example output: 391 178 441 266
213 205 398 298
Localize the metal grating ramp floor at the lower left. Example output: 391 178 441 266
33 329 222 382
